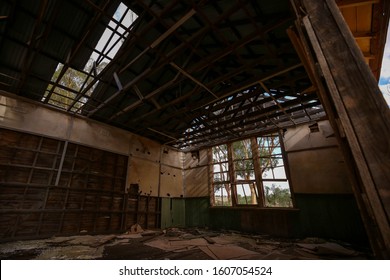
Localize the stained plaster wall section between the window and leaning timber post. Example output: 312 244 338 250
284 121 352 194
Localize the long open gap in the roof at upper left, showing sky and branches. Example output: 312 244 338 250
41 3 138 113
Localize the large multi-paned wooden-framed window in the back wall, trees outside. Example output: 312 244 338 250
211 133 292 207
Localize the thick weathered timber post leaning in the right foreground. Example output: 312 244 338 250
302 0 390 257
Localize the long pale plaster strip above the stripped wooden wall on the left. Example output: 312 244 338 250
0 96 134 155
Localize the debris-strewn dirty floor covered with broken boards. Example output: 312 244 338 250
0 228 372 260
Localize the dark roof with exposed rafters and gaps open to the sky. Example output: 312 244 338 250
0 0 383 150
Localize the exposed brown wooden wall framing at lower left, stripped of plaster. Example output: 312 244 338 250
0 129 127 239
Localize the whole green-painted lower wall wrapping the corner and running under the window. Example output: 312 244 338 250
165 194 367 244
